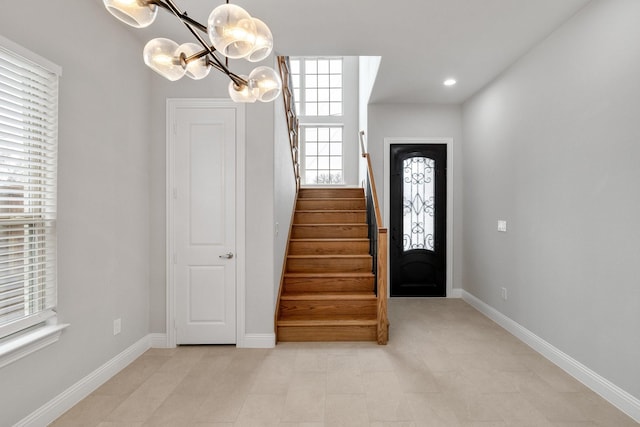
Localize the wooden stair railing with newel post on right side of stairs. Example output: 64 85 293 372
360 131 389 344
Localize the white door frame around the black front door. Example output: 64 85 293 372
383 137 460 298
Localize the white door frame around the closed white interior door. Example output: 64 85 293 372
166 98 246 348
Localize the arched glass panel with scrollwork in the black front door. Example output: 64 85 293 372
402 157 435 252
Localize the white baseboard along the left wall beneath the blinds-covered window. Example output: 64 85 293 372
13 335 151 427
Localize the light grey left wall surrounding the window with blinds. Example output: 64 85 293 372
0 1 150 426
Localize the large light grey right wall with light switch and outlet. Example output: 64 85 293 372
463 0 640 398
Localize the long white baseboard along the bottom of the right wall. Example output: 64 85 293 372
462 290 640 422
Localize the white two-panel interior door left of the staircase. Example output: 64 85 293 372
169 106 236 344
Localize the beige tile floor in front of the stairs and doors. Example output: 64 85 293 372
53 299 638 427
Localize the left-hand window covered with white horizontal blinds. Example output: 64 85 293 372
0 38 60 339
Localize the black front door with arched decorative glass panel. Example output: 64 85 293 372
389 144 447 297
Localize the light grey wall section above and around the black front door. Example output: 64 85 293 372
367 104 462 288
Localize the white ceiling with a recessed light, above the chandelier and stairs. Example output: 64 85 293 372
126 0 589 104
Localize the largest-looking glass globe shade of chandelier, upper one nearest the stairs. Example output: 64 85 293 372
207 4 256 59
